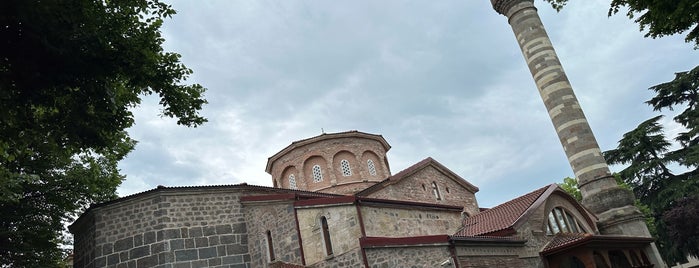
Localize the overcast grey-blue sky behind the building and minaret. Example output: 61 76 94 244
119 0 699 207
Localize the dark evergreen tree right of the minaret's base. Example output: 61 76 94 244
604 77 699 263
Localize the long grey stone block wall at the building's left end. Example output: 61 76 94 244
73 188 260 268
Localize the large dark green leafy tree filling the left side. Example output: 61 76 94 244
0 0 206 267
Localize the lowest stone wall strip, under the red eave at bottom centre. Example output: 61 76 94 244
365 245 453 268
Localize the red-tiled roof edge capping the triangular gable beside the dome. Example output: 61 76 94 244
355 157 478 196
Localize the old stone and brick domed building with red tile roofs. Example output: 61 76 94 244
70 131 657 268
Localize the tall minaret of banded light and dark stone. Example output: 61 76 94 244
491 0 665 267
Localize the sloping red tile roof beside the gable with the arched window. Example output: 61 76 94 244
454 184 558 236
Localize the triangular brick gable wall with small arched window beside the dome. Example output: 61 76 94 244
360 166 478 215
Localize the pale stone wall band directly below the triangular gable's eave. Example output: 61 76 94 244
361 206 461 237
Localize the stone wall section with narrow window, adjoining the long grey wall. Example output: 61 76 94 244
243 200 302 267
